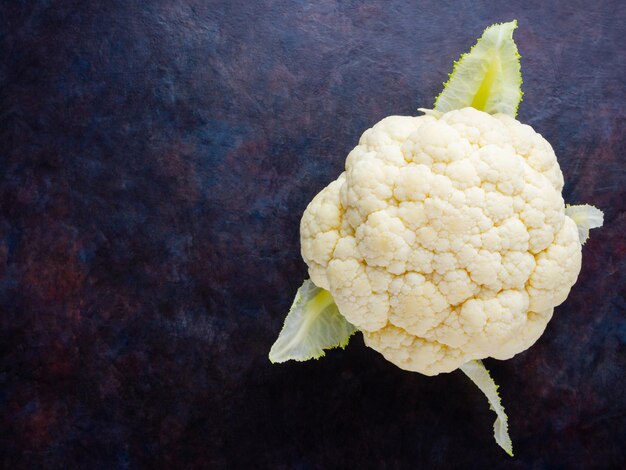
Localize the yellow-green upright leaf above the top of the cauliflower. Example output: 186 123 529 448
435 20 522 117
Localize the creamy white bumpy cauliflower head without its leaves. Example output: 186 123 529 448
300 107 581 375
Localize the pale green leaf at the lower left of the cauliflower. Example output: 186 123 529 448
269 279 356 363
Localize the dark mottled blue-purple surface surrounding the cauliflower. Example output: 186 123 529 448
0 0 626 469
